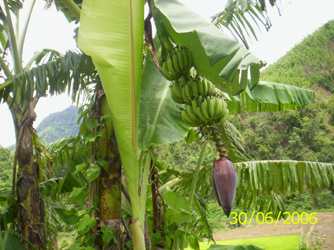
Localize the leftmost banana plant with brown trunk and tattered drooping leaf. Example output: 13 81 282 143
0 0 95 249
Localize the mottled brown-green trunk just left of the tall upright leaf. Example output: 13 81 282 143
95 87 122 250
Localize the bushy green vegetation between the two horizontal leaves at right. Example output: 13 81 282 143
238 103 334 162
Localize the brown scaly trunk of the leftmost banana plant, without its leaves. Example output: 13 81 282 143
14 101 46 250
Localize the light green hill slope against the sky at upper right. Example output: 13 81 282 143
263 20 334 92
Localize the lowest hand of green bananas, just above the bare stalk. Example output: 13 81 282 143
181 96 228 127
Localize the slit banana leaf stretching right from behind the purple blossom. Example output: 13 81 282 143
234 160 334 215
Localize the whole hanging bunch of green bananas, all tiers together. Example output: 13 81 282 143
161 43 228 127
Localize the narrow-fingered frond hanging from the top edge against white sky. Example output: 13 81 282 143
212 0 279 48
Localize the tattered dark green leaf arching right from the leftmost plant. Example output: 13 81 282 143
0 51 97 104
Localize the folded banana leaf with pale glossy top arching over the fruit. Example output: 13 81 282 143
153 0 262 95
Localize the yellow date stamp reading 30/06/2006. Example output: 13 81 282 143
230 211 318 225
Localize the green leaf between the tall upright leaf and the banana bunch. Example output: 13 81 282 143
139 58 188 149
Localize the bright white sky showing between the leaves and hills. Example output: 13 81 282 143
0 0 334 147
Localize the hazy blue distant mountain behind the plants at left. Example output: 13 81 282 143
37 106 79 144
